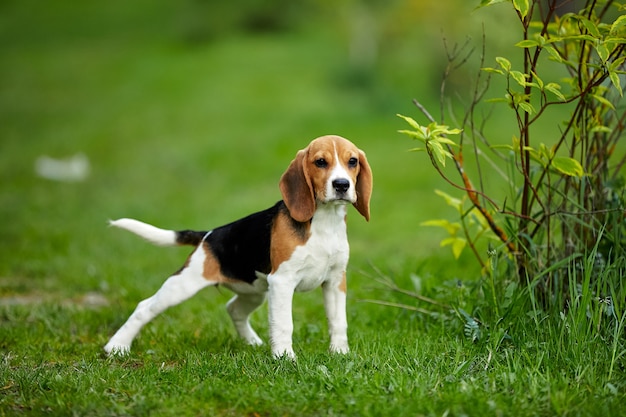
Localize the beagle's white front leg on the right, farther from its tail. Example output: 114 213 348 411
322 272 349 353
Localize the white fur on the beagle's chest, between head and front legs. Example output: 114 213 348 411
275 204 349 291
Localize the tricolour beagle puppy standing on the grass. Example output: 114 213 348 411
104 136 372 358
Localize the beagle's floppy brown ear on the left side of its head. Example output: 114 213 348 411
279 149 315 222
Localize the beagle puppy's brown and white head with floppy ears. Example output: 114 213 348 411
280 135 372 222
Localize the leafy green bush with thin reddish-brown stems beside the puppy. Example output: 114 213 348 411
401 0 626 301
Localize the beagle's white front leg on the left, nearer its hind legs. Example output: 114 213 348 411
267 275 296 359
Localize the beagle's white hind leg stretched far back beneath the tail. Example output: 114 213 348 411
104 245 218 354
